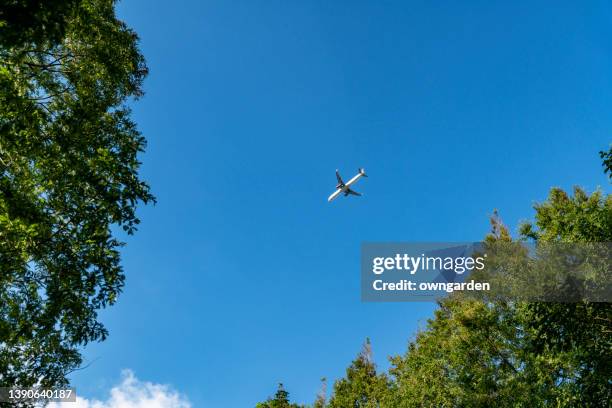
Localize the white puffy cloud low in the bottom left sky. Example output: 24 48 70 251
49 370 191 408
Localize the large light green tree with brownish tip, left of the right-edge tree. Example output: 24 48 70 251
390 239 542 407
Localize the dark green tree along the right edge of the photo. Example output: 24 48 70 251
521 186 612 407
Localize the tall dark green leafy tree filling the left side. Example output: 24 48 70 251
0 0 154 386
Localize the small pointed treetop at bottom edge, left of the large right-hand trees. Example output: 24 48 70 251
328 339 391 408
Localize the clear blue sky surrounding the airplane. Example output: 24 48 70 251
72 0 612 408
